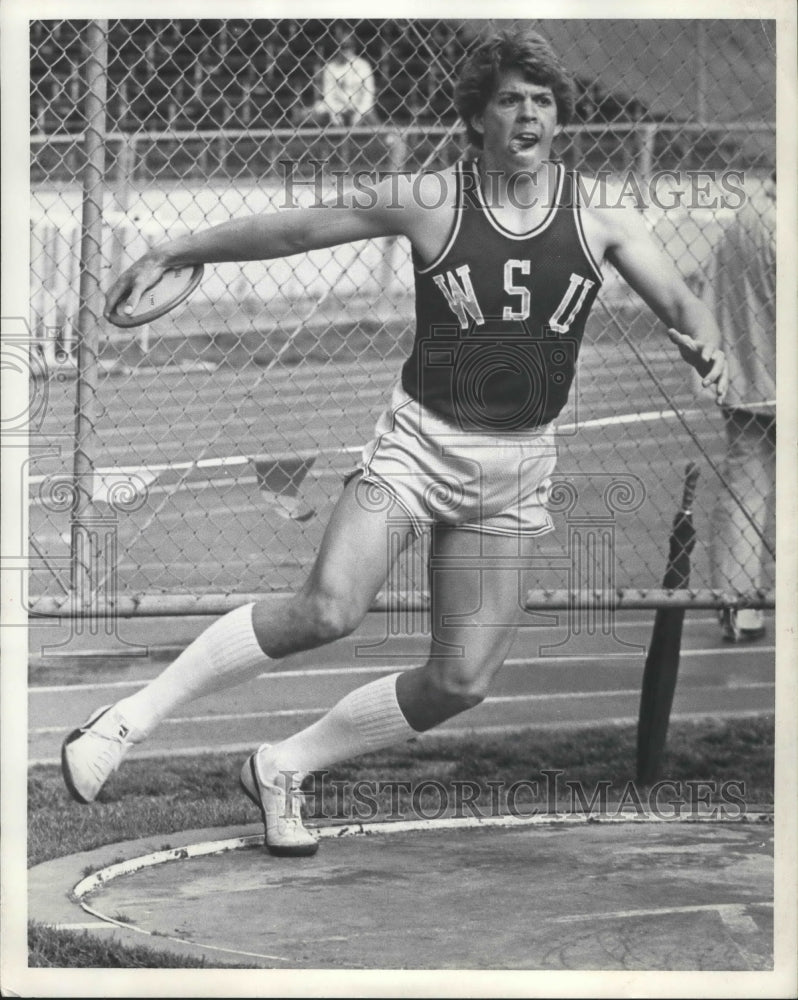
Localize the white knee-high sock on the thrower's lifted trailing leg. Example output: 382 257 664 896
117 604 269 736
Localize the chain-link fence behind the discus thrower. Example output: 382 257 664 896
30 20 775 610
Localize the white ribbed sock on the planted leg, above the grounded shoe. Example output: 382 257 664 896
259 674 418 780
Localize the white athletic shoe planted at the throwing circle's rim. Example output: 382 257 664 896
239 743 319 858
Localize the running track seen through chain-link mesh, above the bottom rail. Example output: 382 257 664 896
31 343 768 594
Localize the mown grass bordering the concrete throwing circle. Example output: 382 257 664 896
28 716 774 967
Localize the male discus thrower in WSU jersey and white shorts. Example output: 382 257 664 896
62 34 726 855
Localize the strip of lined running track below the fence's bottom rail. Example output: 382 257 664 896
29 612 775 763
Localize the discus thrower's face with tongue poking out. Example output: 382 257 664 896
473 70 557 168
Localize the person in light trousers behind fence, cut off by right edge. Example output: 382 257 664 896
704 173 776 642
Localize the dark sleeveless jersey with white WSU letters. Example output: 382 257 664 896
402 163 602 433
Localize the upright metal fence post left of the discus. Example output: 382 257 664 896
70 20 108 604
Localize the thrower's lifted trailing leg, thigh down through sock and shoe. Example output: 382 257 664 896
62 477 412 802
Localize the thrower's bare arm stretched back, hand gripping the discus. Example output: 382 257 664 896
105 180 416 318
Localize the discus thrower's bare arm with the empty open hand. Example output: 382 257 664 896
602 208 728 403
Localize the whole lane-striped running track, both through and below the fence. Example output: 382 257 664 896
29 332 775 762
